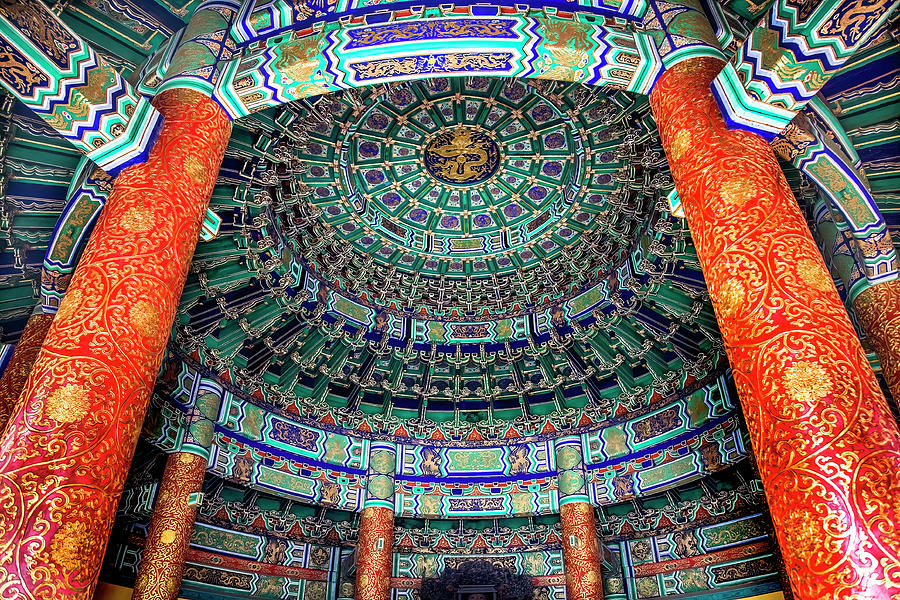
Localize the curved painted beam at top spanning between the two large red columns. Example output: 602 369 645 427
209 12 662 118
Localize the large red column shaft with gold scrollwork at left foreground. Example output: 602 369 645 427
0 89 231 600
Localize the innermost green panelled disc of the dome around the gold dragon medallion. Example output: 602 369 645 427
289 78 625 290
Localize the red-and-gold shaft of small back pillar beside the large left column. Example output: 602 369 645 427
133 452 206 600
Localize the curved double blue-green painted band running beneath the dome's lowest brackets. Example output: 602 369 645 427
151 362 746 518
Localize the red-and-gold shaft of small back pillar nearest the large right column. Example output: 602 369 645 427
559 502 603 600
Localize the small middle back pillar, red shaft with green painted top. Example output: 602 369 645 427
356 441 397 600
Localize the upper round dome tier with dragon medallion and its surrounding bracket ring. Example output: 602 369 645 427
280 77 661 321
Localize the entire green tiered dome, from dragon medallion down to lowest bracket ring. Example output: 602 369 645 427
177 77 720 438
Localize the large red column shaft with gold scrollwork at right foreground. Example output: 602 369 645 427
650 58 900 600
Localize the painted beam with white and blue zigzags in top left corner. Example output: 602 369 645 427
0 0 162 175
